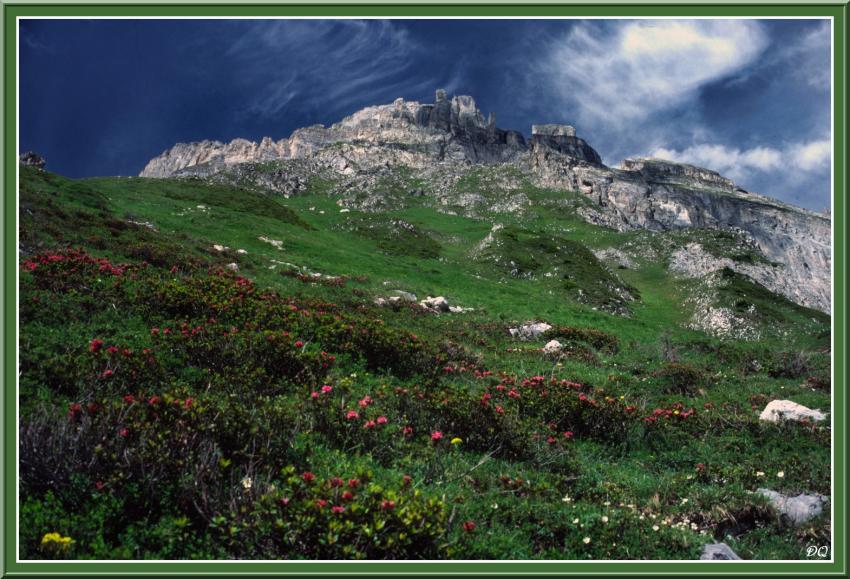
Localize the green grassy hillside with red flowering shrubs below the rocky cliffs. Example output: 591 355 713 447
20 167 831 559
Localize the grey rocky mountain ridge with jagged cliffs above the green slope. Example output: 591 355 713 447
140 90 831 313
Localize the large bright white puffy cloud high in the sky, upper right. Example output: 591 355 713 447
533 20 767 125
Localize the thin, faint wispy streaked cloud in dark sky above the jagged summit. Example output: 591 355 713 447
224 20 457 117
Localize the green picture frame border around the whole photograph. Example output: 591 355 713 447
0 1 848 577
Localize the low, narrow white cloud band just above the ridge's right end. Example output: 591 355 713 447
650 139 831 183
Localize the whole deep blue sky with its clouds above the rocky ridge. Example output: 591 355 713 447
20 20 830 209
